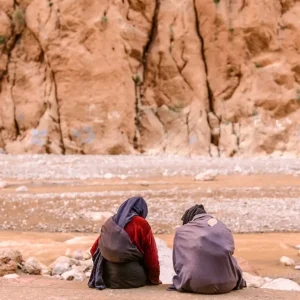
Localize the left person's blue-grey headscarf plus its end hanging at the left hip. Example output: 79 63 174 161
88 197 148 290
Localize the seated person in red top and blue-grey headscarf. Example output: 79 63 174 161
88 197 160 290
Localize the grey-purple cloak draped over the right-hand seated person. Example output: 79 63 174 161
173 214 246 294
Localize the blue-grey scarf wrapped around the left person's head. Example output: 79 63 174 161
113 197 148 228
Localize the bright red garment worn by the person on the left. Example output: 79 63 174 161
91 216 159 284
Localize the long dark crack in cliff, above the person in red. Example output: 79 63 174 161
133 0 160 150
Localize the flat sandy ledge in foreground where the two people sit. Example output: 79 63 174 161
0 277 299 300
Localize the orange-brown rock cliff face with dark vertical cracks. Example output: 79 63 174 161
0 0 300 156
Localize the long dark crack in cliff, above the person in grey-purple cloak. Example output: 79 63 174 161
193 0 220 156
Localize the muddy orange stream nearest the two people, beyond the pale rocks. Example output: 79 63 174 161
0 231 300 283
